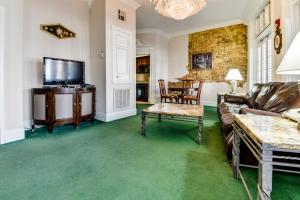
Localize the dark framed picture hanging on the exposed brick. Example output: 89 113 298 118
191 52 212 70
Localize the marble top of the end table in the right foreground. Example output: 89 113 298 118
233 114 300 150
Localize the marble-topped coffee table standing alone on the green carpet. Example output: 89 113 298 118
141 103 204 144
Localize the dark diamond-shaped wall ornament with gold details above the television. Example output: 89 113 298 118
41 24 76 39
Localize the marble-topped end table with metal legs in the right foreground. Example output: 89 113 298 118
232 115 300 200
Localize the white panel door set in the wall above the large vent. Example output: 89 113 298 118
112 27 132 84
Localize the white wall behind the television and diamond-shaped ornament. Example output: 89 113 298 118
23 0 91 128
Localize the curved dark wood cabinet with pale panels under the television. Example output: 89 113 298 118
32 87 96 133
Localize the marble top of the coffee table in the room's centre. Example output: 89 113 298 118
143 103 204 117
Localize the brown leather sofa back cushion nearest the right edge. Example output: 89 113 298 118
263 82 300 113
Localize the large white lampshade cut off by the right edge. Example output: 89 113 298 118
276 32 300 75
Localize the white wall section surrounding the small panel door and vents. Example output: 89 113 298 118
104 0 137 121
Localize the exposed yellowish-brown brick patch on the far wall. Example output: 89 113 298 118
188 24 248 84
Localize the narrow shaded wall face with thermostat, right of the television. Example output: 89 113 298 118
90 0 106 121
